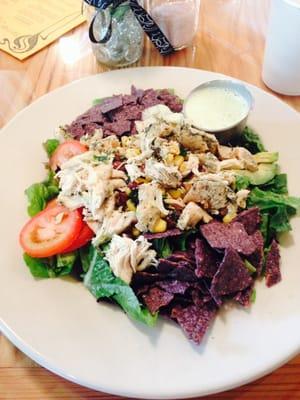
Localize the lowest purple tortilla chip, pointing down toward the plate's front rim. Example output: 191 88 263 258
171 304 216 344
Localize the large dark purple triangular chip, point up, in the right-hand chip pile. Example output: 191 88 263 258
210 247 253 297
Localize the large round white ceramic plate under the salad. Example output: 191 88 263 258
0 67 300 399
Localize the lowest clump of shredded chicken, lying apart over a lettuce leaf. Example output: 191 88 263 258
105 235 157 284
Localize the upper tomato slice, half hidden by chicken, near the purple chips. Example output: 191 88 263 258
50 140 88 171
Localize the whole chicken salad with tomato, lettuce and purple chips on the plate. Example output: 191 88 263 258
20 87 300 344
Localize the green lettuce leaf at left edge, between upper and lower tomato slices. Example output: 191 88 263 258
25 171 59 217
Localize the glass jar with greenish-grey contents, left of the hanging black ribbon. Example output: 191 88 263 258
84 2 144 67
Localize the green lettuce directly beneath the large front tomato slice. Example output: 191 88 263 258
23 252 77 278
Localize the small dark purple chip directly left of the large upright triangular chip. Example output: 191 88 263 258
195 239 219 278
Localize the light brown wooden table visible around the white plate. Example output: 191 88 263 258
0 0 300 400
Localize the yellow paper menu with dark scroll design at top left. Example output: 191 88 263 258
0 0 85 60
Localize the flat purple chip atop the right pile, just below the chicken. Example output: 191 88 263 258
200 221 256 255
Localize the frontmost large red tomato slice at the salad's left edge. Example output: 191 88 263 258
20 205 83 258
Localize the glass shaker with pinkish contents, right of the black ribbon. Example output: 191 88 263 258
147 0 200 50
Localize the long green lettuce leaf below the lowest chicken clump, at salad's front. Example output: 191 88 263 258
84 246 157 326
